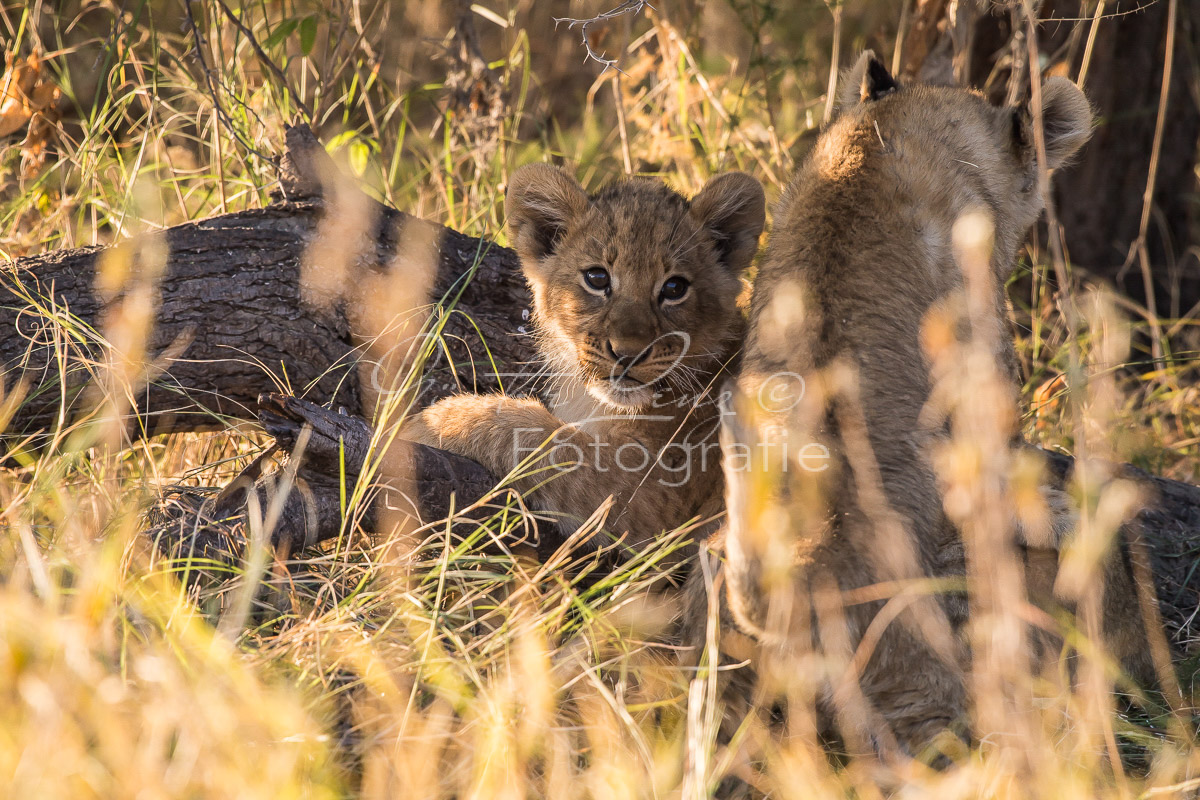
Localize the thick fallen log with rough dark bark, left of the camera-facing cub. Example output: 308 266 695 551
0 195 532 440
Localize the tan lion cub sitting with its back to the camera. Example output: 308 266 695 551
700 54 1108 754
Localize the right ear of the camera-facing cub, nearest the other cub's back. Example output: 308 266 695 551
691 173 767 273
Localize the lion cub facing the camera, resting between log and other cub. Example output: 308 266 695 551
403 164 766 548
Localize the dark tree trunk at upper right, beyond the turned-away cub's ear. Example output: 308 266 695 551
1055 1 1200 318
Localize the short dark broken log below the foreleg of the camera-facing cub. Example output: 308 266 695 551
148 395 565 564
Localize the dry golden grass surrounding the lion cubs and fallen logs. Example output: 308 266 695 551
0 0 1200 800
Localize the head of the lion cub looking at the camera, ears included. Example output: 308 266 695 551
505 164 766 411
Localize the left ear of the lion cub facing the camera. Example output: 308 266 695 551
504 164 588 261
